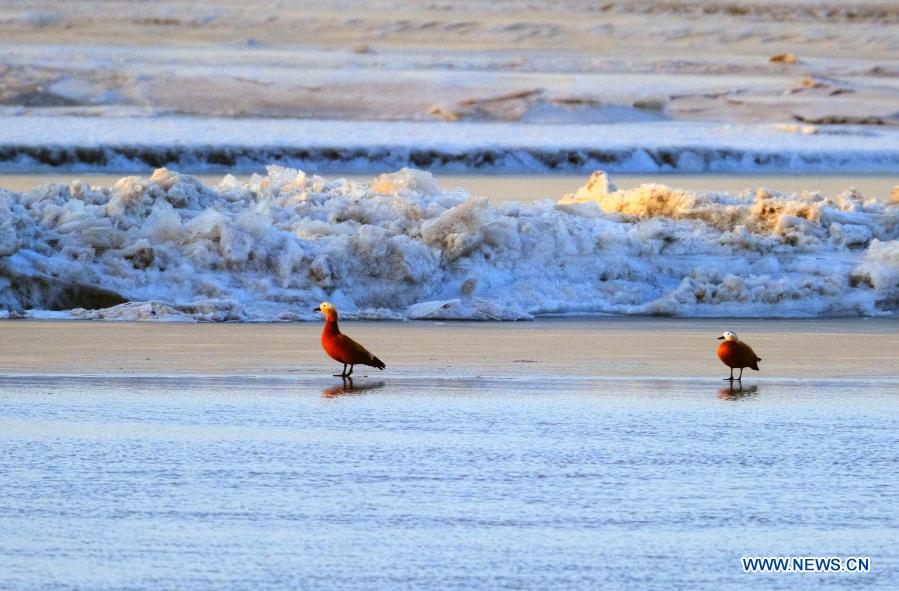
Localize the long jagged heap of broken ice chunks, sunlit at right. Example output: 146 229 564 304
0 166 899 321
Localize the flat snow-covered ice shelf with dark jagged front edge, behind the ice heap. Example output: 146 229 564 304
0 116 899 174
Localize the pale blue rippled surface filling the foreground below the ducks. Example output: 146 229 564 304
0 377 899 591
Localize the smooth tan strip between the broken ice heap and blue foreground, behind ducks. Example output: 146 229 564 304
0 318 899 380
